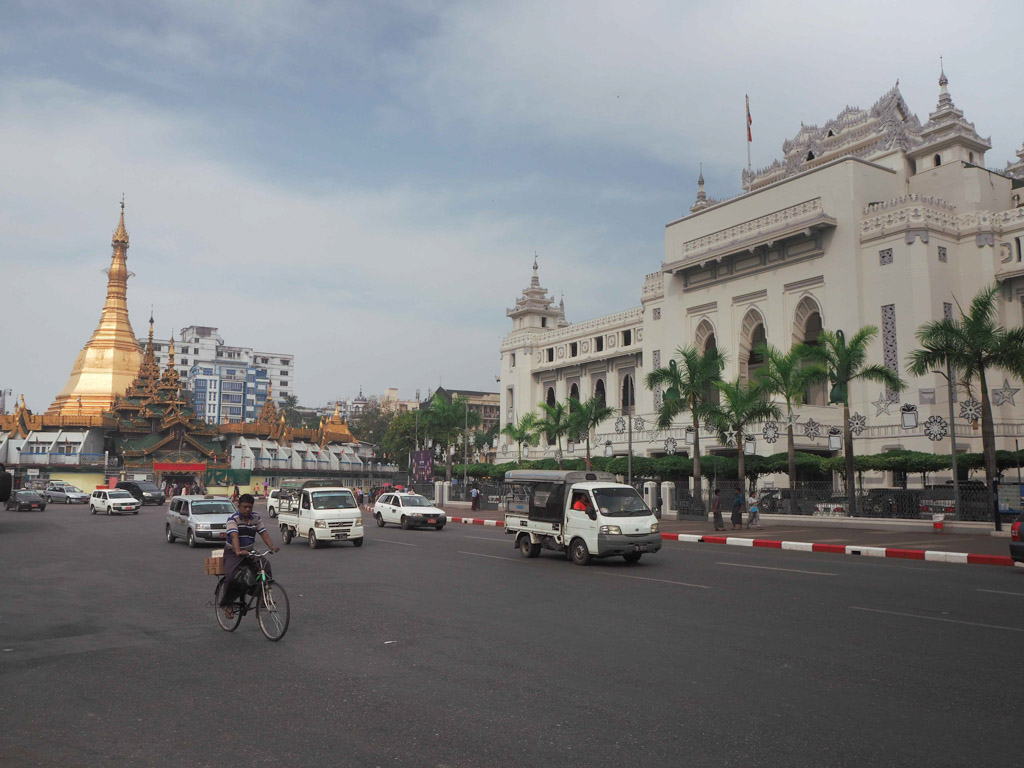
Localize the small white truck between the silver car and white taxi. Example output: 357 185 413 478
278 481 362 549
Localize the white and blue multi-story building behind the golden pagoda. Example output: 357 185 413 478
141 326 295 423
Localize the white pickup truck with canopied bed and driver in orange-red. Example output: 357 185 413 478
505 469 662 565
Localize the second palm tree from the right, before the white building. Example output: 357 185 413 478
811 326 906 514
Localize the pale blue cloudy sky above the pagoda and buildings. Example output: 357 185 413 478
0 0 1024 411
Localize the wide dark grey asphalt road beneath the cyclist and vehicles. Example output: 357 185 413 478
0 507 1024 767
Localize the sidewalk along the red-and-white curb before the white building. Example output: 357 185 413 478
434 503 1010 556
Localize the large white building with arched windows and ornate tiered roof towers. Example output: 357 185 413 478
499 70 1024 481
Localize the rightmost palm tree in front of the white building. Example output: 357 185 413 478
907 285 1024 487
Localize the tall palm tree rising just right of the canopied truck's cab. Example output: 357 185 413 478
645 346 725 500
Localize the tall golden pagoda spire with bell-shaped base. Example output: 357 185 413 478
46 200 142 416
